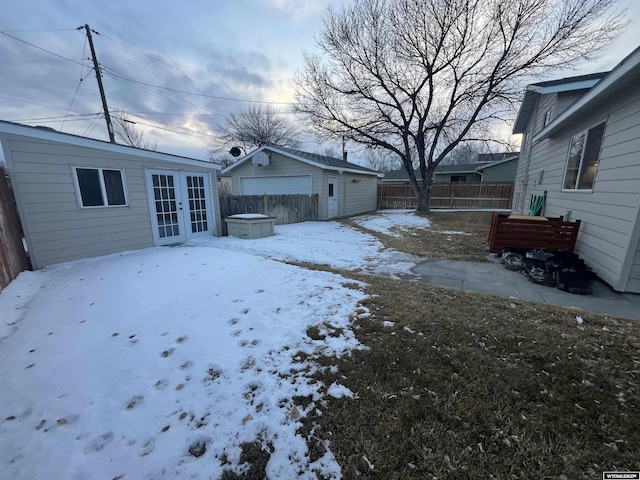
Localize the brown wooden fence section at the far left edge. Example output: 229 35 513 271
0 167 29 290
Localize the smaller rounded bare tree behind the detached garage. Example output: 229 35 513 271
209 105 300 163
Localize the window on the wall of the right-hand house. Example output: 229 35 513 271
562 122 605 190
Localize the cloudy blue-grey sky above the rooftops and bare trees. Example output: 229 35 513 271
0 0 640 159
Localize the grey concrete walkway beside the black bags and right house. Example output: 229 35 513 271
411 258 640 319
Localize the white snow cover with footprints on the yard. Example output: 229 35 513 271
0 211 429 480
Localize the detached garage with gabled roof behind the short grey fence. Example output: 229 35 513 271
222 145 383 220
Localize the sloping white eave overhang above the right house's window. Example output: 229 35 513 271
535 47 640 139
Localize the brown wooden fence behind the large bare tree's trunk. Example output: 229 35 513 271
378 182 513 210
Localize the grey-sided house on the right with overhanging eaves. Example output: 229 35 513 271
513 48 640 293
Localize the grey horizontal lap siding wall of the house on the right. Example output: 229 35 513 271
519 86 640 292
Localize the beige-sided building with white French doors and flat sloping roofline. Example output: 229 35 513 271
0 121 221 269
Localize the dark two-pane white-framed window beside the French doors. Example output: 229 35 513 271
75 168 127 207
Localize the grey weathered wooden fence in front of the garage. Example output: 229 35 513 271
218 193 318 235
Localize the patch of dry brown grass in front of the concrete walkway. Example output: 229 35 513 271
302 272 640 479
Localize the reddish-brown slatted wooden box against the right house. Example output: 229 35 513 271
489 213 580 253
